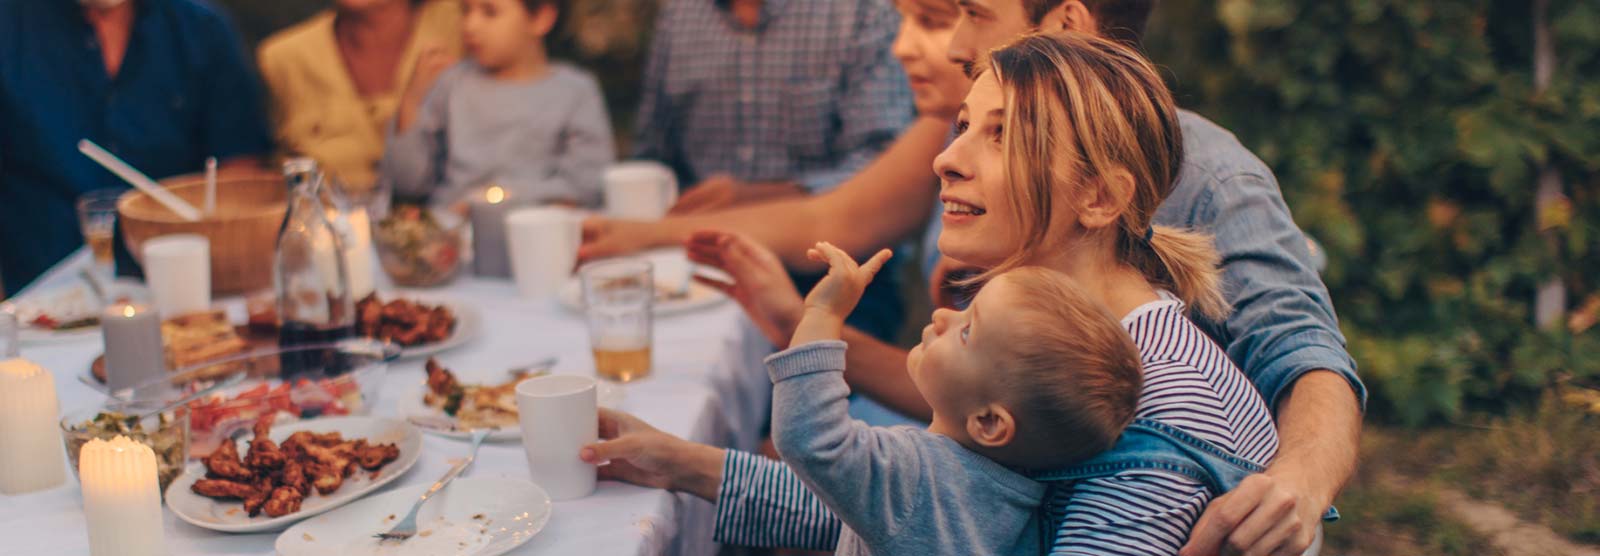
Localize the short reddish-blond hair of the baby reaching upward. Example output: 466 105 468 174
997 267 1144 468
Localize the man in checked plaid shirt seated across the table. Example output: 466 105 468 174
634 0 912 214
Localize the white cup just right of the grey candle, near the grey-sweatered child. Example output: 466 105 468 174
506 206 582 299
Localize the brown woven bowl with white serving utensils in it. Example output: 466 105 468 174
117 173 288 296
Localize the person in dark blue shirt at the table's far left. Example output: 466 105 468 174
0 0 272 296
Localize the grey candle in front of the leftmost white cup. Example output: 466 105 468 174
101 304 166 391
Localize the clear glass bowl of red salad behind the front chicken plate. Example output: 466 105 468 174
111 339 400 457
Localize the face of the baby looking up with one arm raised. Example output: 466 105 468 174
906 275 1018 439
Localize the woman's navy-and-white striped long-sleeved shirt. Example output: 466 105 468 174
715 292 1278 554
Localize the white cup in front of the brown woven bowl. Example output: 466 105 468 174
144 233 211 318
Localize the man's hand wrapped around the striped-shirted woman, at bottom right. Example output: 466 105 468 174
1178 470 1328 556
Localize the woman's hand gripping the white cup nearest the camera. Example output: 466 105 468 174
578 407 725 500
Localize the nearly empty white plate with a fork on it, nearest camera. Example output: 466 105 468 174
274 479 552 556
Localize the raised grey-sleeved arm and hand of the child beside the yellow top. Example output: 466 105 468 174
378 64 462 197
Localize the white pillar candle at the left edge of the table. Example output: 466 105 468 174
0 358 67 494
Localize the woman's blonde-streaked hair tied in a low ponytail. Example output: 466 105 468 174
978 32 1229 320
